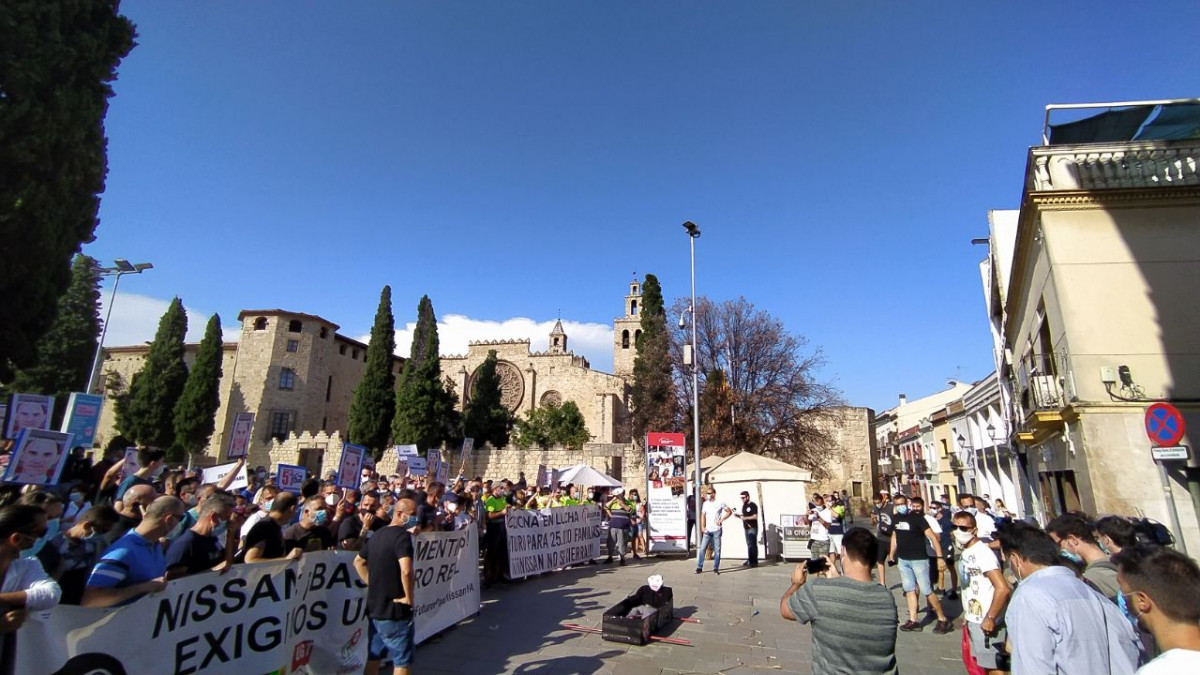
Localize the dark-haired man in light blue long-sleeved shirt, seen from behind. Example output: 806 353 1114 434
997 521 1140 675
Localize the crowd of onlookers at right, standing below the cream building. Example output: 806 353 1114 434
780 492 1200 675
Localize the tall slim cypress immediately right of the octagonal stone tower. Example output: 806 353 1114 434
349 286 396 458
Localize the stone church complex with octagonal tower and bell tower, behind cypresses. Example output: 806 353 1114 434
96 281 641 468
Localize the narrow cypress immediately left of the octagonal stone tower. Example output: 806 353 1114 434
175 315 222 454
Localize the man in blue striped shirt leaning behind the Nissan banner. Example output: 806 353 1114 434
79 496 187 607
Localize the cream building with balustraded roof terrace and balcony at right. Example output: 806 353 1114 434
983 100 1200 552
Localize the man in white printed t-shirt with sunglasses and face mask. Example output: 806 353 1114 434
953 510 1013 675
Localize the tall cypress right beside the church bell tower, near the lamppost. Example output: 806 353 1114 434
630 274 678 443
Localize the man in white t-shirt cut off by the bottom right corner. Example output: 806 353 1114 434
1112 545 1200 675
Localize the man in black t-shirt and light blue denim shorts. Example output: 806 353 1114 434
888 495 954 634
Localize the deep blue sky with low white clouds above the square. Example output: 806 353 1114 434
85 0 1200 410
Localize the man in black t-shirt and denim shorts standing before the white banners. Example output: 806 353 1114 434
354 498 416 675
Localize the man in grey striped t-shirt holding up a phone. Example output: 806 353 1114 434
779 527 896 674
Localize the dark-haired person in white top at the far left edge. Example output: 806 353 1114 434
0 504 62 634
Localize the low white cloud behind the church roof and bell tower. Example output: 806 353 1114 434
359 313 612 372
